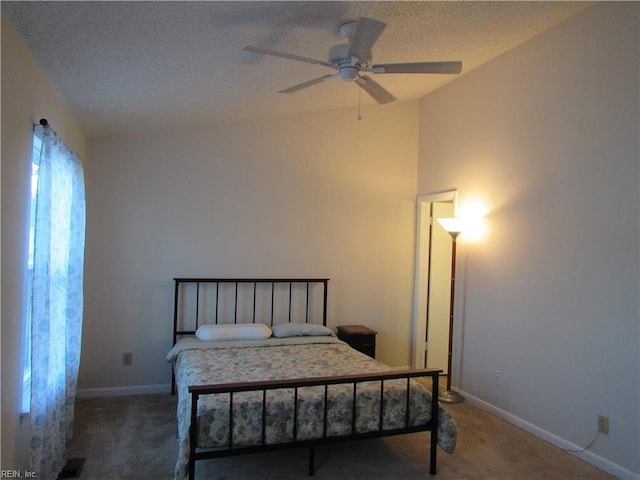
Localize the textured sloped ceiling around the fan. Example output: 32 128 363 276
2 1 588 137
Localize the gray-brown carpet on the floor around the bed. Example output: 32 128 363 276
68 394 614 480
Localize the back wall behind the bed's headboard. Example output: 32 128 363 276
79 101 418 389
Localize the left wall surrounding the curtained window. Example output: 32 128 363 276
0 15 86 469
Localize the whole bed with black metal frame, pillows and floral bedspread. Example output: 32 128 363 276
167 278 456 480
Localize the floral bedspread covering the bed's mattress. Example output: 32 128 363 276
167 337 456 480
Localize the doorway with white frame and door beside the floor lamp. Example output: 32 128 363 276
412 190 457 375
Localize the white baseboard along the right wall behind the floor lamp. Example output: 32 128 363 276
454 389 640 480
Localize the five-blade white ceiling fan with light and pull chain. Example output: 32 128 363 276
243 17 462 104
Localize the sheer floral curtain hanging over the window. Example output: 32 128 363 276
30 126 85 480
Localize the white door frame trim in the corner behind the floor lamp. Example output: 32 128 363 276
411 189 458 368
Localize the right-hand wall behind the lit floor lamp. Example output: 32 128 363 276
418 2 640 478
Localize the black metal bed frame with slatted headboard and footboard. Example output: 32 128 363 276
172 278 442 480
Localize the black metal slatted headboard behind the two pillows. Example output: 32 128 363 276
173 277 329 345
